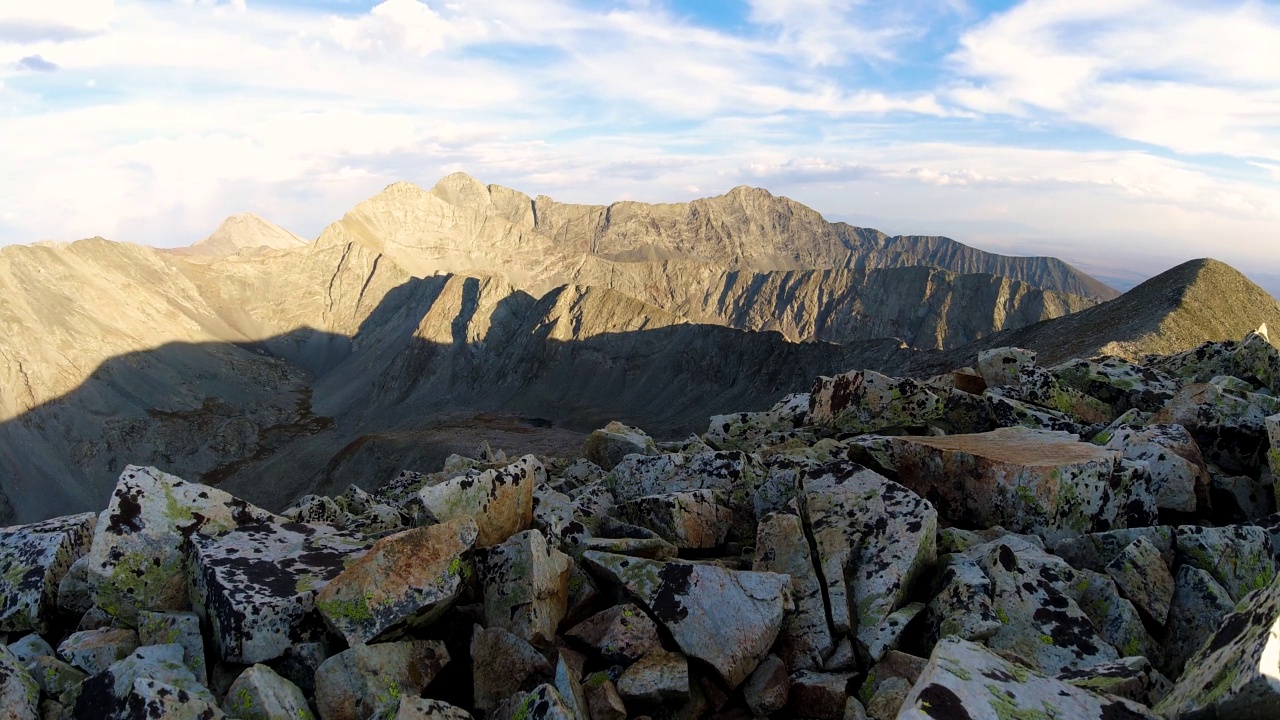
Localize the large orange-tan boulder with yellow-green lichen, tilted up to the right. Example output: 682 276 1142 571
315 518 479 644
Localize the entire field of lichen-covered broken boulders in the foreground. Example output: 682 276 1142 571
0 328 1280 720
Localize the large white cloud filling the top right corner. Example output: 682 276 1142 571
950 0 1280 159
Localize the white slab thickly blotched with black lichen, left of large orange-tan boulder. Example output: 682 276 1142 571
191 515 371 664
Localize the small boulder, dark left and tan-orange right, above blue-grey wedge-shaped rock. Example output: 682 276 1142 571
618 489 733 548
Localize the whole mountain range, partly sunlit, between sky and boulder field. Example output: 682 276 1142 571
0 174 1280 521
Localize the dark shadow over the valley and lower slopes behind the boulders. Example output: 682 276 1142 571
0 275 910 523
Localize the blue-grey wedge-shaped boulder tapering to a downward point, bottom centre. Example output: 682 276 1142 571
582 552 791 688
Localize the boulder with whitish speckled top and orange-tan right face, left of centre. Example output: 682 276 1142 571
417 455 547 547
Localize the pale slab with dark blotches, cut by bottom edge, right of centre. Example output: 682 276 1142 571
897 638 1160 720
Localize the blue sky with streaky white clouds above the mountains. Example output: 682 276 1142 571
0 0 1280 293
